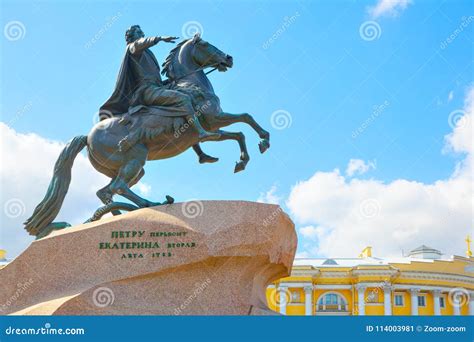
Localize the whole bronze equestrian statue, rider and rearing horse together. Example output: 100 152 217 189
25 26 270 238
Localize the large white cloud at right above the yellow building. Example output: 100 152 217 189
287 87 474 257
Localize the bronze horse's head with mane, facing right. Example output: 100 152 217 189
161 33 234 79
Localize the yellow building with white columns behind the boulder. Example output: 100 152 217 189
267 246 474 315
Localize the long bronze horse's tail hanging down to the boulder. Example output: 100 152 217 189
24 135 87 236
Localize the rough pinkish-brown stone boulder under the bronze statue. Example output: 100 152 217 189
0 201 297 315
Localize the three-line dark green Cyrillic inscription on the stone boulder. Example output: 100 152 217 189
99 230 196 260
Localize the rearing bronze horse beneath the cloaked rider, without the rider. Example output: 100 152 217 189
25 35 270 238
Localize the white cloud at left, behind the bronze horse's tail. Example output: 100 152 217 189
0 122 109 258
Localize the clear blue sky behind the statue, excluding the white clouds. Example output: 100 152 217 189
1 0 474 255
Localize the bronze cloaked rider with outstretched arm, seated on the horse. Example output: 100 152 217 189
101 25 219 146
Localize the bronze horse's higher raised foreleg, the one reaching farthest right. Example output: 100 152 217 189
205 112 270 153
